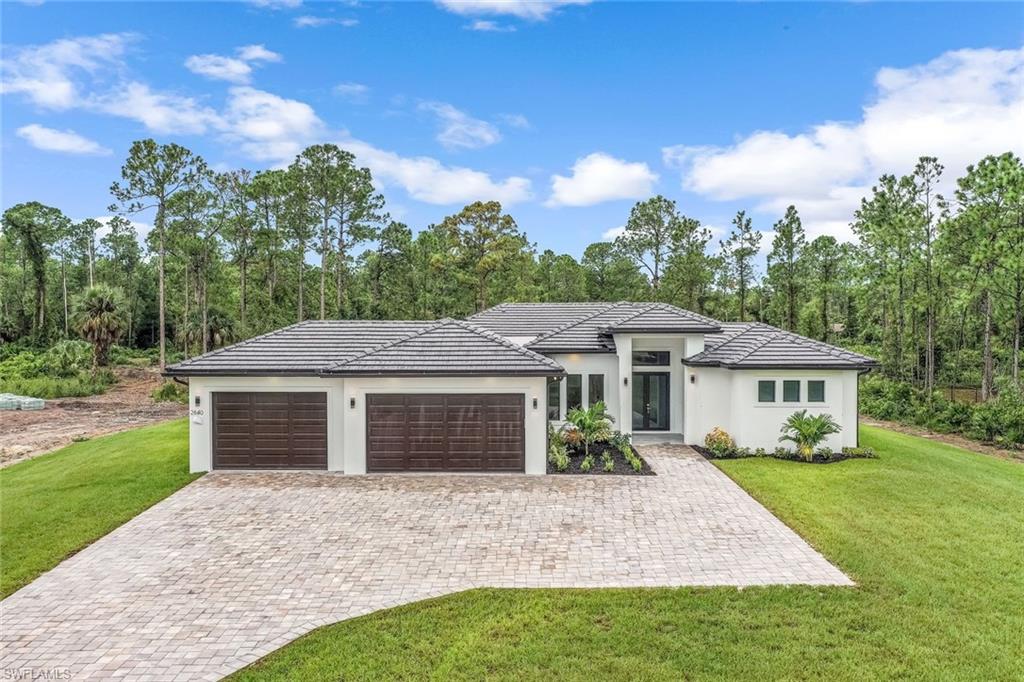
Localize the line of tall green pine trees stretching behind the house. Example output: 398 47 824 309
0 139 1024 398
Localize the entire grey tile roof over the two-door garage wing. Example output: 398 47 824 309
166 319 563 377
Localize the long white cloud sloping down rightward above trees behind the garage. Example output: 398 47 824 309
338 139 530 205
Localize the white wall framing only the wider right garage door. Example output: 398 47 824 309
332 377 548 474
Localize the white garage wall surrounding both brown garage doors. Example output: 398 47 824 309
188 377 548 474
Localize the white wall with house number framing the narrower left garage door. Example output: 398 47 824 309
188 377 343 471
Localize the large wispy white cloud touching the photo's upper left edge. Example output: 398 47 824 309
0 33 134 110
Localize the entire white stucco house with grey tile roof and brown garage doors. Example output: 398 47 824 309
166 302 874 474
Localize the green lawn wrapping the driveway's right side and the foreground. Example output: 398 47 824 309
236 428 1024 681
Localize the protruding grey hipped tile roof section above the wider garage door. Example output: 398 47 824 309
324 319 565 377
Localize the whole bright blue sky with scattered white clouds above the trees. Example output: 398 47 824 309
0 0 1024 256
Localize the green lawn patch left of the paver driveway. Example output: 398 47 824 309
0 420 197 597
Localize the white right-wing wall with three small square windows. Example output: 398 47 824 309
686 368 858 451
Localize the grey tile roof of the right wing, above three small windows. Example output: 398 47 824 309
683 323 878 370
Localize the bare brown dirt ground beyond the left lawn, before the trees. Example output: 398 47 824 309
0 368 187 467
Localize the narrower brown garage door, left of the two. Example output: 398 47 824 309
213 392 327 469
